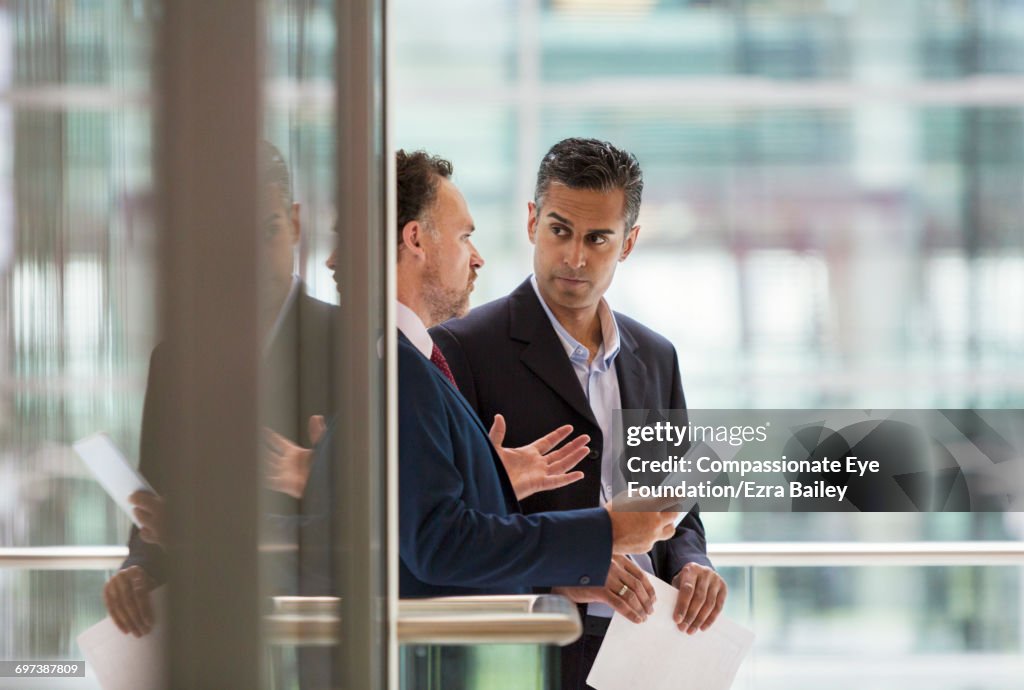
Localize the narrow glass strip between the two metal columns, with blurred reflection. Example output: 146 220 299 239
261 0 347 690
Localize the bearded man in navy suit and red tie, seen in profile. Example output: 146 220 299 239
387 152 678 597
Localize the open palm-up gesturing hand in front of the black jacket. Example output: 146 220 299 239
489 415 590 501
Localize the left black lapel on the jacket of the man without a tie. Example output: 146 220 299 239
509 278 598 426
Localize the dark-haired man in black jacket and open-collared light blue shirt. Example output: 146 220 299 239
431 139 726 690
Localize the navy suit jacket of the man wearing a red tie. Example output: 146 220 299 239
398 335 611 597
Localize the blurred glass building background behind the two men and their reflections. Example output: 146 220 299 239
0 0 1024 690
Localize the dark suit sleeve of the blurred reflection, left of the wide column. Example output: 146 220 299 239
121 345 167 584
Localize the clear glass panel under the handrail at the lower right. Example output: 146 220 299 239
726 566 1024 690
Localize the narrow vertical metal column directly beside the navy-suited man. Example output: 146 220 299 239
334 0 396 690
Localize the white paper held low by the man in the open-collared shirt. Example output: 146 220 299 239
587 576 754 690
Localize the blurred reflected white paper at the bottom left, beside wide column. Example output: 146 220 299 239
78 587 167 690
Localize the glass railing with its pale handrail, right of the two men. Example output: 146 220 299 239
709 542 1024 690
